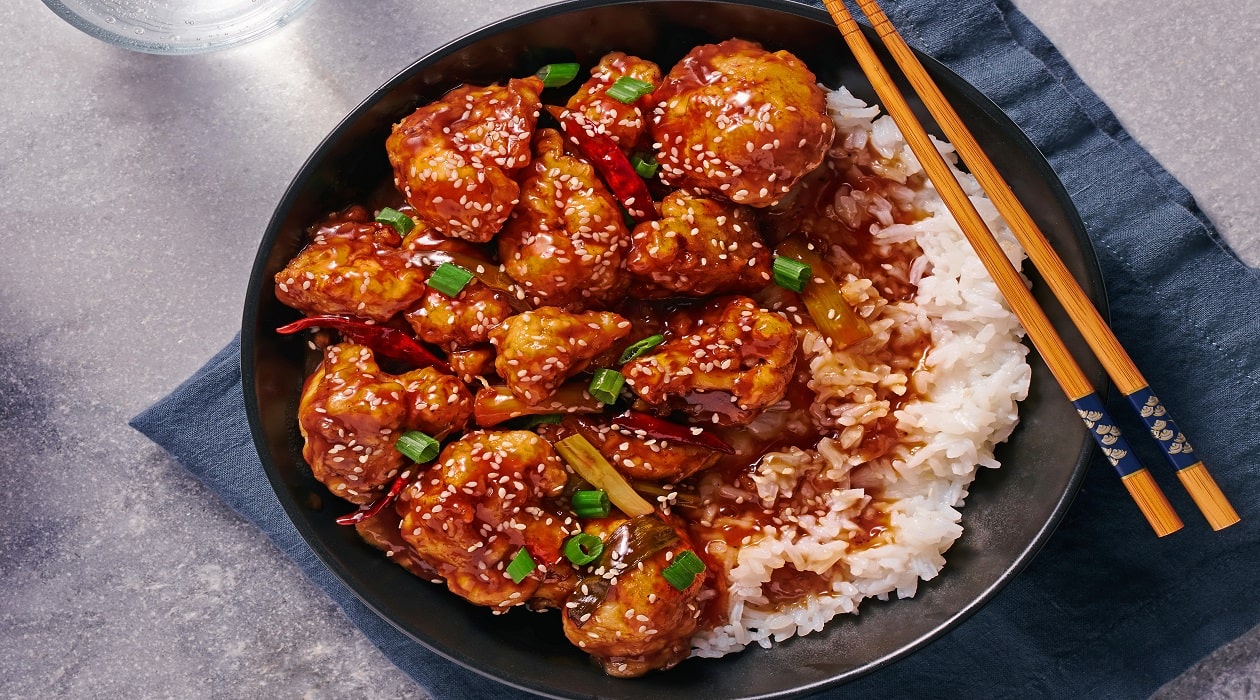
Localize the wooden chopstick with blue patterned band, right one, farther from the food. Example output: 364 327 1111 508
857 0 1239 530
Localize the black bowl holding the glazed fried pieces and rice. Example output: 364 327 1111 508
242 0 1104 700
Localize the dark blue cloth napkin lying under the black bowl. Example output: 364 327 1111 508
132 0 1260 699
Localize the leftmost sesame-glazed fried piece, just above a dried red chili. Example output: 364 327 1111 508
276 206 428 322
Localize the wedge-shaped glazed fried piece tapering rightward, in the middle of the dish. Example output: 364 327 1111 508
490 306 630 404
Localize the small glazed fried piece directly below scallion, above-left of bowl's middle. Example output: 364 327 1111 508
406 279 513 347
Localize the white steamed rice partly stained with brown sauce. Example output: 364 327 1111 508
692 88 1031 656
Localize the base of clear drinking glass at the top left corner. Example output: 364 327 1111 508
44 0 314 54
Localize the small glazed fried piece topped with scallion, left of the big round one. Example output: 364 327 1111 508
567 52 660 150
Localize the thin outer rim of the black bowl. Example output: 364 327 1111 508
236 0 1111 700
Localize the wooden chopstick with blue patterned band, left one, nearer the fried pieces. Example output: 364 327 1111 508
824 0 1182 538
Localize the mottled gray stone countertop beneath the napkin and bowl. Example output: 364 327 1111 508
0 0 1260 697
